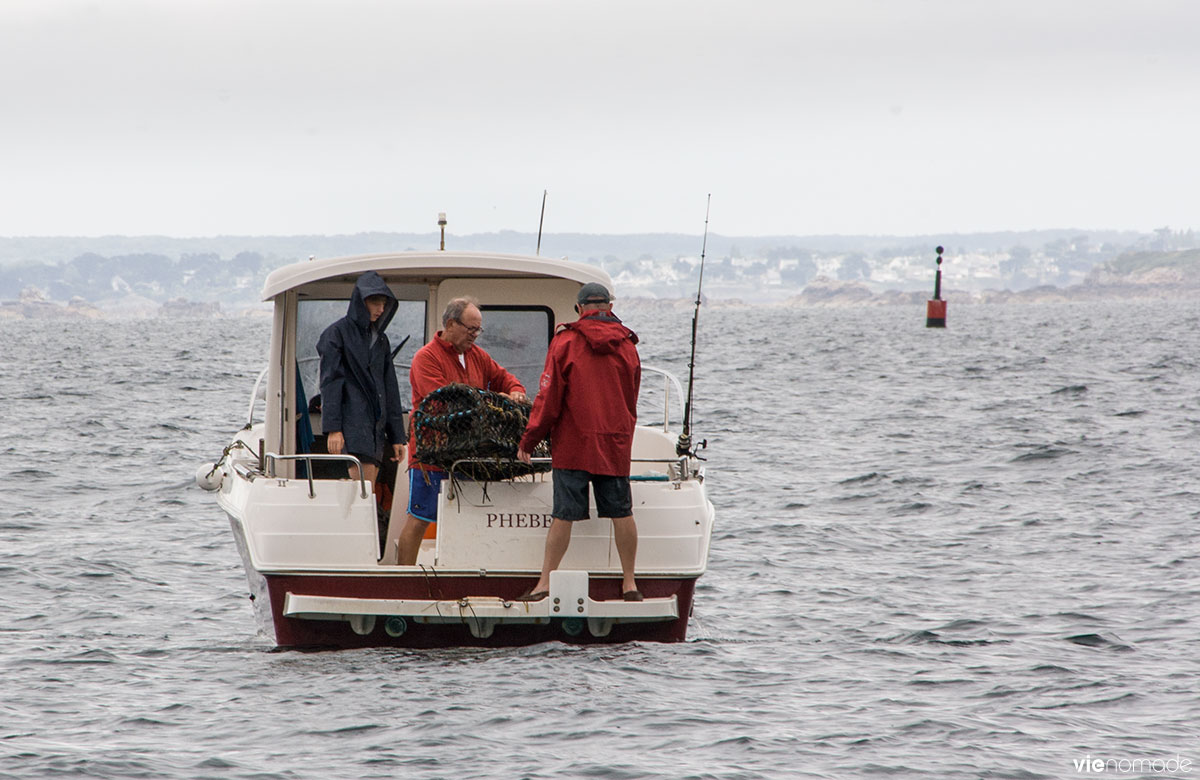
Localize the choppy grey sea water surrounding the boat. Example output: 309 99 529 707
0 302 1200 780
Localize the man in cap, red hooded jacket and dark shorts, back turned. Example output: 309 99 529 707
517 282 642 601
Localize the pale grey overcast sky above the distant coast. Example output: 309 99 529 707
0 0 1200 236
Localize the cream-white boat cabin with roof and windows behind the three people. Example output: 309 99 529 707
256 252 612 460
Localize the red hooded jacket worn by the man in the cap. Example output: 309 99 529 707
520 311 642 476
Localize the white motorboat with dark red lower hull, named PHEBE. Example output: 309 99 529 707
197 251 714 647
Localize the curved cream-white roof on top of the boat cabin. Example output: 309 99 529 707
263 251 612 301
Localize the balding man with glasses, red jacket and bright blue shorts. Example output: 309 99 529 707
397 298 529 565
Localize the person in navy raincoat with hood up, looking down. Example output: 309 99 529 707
317 271 408 482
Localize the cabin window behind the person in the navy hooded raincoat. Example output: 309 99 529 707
296 299 425 408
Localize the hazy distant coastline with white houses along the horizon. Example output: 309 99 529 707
0 228 1200 319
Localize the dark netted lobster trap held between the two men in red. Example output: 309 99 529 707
413 384 551 481
